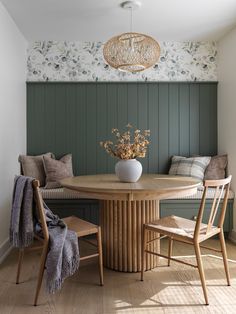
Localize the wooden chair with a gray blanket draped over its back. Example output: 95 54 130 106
16 180 103 305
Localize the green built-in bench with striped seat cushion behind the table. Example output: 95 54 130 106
41 188 234 236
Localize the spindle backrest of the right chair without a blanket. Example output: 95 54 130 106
194 176 232 237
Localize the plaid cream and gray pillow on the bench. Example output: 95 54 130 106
169 156 211 180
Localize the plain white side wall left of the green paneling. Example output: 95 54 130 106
0 2 27 260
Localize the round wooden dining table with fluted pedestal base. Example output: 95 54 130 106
61 174 201 272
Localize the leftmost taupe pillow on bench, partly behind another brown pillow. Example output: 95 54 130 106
18 153 55 186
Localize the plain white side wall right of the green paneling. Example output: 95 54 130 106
218 28 236 241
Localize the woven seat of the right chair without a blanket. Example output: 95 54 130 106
146 215 219 242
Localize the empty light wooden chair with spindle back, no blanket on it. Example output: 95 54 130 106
141 176 231 305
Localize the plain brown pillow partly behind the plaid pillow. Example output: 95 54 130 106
204 155 228 180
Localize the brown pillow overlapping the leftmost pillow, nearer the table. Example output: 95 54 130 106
43 154 73 189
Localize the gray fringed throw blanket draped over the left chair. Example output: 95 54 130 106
10 176 79 293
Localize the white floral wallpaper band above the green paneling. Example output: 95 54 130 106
27 41 217 81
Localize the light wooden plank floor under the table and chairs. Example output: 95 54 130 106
0 239 236 314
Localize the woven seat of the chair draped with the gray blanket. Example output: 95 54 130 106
63 216 98 237
